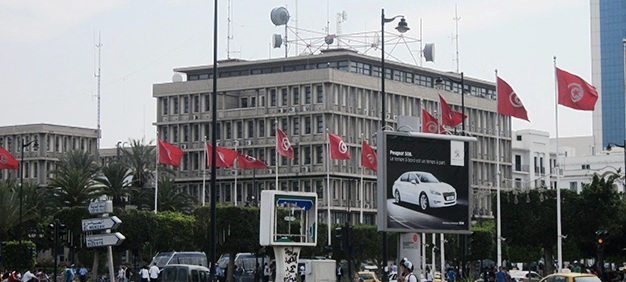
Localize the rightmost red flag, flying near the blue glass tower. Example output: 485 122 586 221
556 68 596 111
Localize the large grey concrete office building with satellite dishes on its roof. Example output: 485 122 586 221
153 50 512 224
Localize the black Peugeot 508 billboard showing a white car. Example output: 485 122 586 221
378 131 476 233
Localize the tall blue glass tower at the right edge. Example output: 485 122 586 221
590 0 626 152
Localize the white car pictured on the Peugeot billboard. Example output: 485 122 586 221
393 171 456 211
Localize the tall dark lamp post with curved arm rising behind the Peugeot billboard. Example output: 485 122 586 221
380 9 410 282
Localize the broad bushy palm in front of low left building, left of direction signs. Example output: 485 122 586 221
50 150 102 207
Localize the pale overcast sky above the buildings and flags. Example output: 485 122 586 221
0 0 592 148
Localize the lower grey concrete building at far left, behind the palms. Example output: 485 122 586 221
0 123 98 186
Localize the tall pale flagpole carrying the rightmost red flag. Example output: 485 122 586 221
553 56 563 272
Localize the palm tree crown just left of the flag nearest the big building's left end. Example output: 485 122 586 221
121 139 156 188
